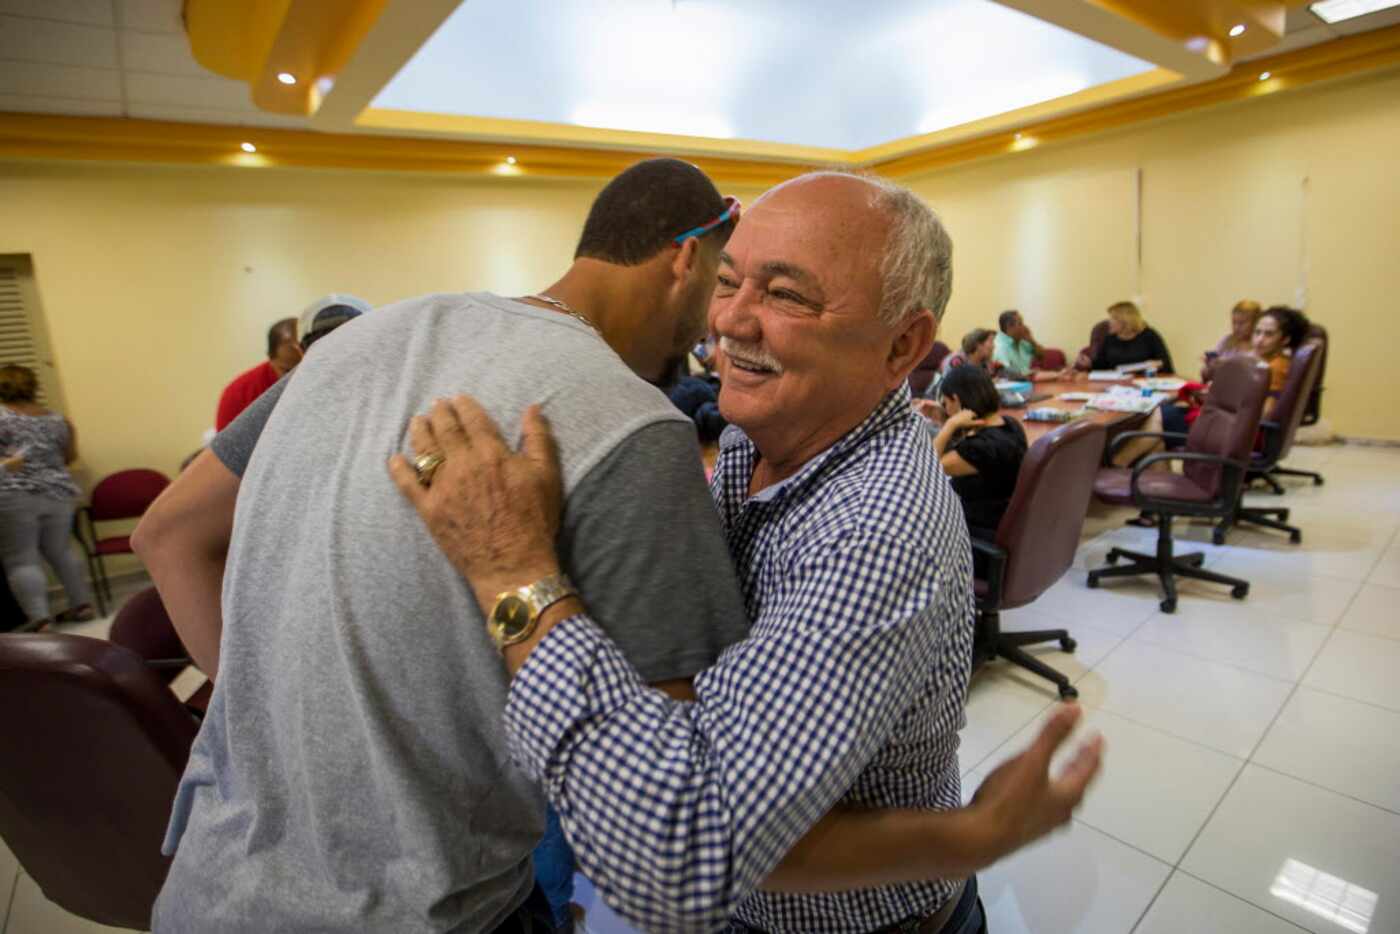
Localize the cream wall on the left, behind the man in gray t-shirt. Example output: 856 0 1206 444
0 162 753 490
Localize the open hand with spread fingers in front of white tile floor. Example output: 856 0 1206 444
970 704 1103 856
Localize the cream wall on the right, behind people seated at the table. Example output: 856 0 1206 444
906 71 1400 440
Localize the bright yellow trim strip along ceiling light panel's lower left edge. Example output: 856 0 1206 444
356 108 857 164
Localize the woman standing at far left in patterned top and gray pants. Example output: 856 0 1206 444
0 364 95 630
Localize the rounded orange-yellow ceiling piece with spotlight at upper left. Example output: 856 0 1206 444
185 0 388 116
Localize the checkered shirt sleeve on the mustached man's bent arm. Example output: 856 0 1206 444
505 529 960 931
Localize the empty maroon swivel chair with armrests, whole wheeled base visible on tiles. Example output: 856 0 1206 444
1089 357 1268 613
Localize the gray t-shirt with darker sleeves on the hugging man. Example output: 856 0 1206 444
154 294 748 933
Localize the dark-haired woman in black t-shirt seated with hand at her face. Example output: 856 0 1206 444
934 365 1026 541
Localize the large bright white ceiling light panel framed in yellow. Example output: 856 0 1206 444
372 0 1152 150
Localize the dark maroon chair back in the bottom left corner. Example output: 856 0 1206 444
0 633 197 930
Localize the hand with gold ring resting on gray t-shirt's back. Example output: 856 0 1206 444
389 396 563 609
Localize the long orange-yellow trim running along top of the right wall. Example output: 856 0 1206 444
871 25 1400 178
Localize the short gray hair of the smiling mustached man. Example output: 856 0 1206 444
795 169 953 326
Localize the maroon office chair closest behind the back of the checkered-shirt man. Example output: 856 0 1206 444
972 421 1103 699
